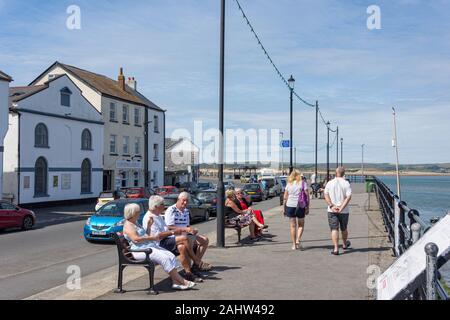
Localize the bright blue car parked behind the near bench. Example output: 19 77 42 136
84 199 148 242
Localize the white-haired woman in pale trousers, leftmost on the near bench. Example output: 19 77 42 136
123 203 195 290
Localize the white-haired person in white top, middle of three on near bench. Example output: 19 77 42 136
142 196 203 282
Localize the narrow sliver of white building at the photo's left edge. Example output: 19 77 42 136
0 70 12 200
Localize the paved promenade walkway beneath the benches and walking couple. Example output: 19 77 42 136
27 185 392 300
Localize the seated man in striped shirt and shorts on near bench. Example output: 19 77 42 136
165 192 212 274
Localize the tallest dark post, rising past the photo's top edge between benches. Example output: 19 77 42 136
217 0 225 248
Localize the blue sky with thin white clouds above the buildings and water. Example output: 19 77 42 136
0 0 450 164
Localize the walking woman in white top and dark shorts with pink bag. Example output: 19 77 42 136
283 170 310 250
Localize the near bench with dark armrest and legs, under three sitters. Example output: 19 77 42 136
113 233 158 295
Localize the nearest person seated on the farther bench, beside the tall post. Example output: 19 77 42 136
225 190 264 240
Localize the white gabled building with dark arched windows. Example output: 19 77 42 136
4 75 104 204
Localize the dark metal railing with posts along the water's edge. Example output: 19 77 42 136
372 177 449 300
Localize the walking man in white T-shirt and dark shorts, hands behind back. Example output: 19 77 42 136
325 167 352 255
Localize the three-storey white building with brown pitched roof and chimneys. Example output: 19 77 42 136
30 62 165 190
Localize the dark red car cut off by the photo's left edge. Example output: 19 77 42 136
0 201 36 230
